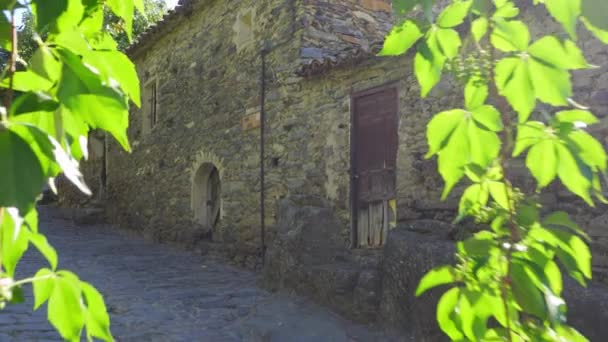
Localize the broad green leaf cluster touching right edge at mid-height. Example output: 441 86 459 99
513 110 607 205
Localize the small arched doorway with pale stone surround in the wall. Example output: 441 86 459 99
191 152 223 231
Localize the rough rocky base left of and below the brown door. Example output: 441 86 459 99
262 197 382 323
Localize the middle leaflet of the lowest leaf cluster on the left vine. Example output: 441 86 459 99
48 277 85 341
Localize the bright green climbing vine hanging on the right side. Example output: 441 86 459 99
380 0 608 341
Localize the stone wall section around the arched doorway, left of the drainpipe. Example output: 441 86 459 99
107 0 298 266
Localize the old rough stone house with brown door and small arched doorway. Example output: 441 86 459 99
70 0 608 335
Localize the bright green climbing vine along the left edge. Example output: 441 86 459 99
0 0 144 341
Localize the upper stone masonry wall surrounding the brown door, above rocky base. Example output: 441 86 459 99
282 1 608 279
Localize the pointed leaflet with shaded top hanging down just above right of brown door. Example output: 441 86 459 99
414 42 445 97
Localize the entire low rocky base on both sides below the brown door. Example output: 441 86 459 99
261 196 608 341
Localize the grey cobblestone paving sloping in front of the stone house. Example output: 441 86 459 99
0 208 396 342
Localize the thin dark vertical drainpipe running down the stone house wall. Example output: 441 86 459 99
260 0 297 267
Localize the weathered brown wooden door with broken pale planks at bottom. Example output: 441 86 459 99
351 87 399 247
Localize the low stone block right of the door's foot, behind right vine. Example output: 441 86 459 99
380 226 608 341
